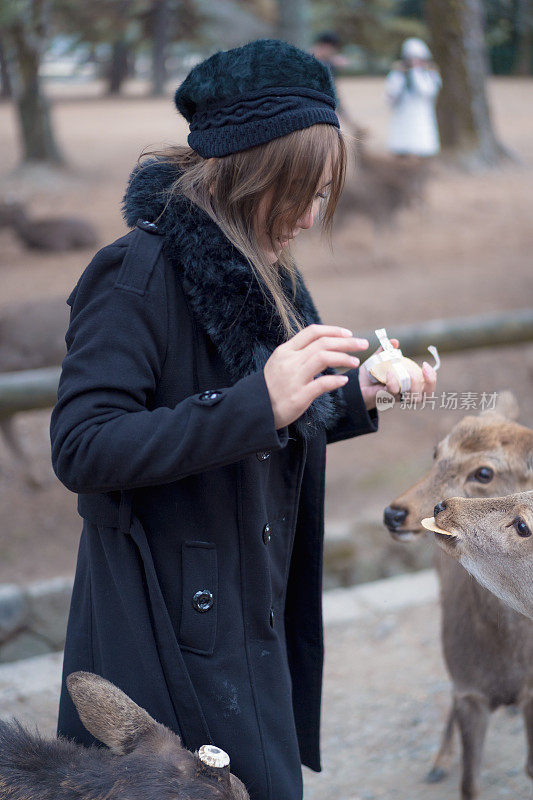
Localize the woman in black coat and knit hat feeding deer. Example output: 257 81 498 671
51 40 435 800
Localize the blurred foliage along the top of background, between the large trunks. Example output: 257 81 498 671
0 0 533 94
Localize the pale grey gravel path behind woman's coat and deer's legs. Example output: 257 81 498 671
0 572 532 800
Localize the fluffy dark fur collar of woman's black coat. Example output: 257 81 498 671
123 160 342 439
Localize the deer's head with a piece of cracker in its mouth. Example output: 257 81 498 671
424 492 533 619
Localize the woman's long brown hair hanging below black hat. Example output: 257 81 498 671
141 124 347 338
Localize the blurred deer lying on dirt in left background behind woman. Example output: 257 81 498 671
0 200 98 253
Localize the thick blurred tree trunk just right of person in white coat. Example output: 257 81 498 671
426 0 507 169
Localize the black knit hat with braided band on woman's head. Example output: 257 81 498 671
174 39 339 158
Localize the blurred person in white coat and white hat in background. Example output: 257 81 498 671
385 38 441 158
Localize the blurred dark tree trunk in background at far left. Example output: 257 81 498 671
9 0 64 164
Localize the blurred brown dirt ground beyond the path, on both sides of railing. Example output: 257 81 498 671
0 78 533 582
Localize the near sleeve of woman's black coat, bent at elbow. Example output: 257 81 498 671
50 240 287 493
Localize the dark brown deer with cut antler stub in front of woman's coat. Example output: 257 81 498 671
0 672 249 800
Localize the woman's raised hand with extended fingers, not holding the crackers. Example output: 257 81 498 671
264 325 368 429
